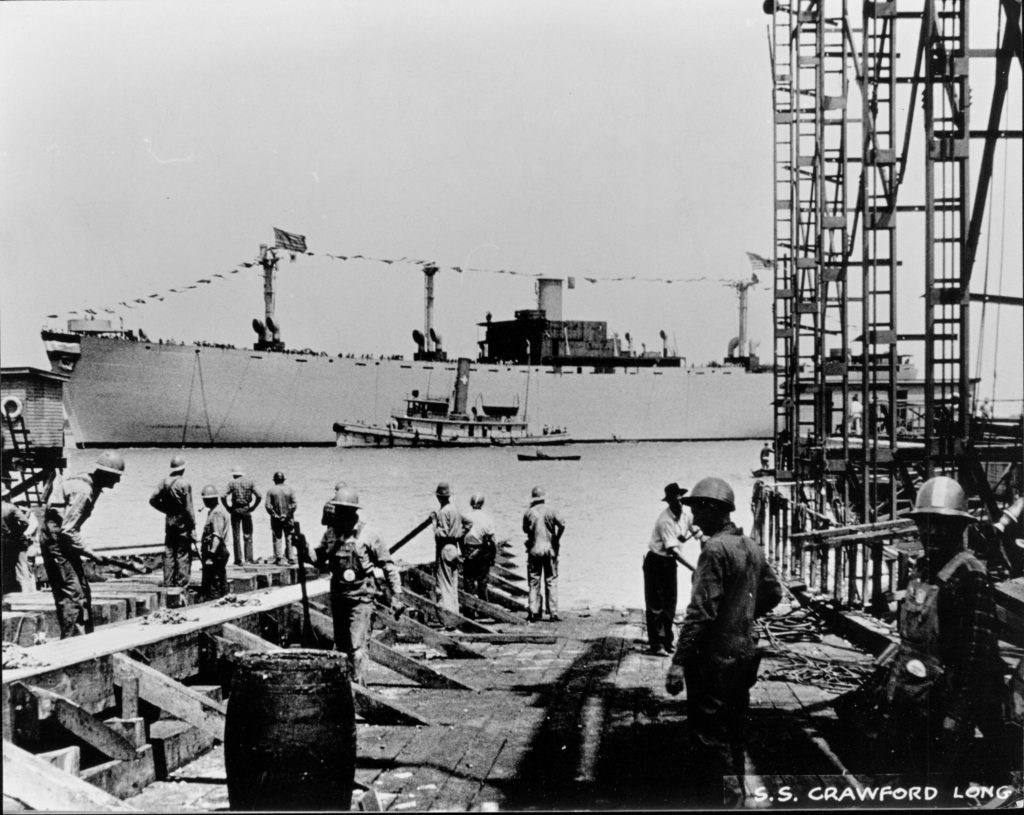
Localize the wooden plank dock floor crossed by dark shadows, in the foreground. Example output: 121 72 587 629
126 609 869 812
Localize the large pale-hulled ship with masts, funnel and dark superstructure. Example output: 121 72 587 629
42 247 773 447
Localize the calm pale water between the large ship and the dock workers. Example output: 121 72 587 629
68 441 762 608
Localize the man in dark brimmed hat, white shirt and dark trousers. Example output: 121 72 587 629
643 482 692 656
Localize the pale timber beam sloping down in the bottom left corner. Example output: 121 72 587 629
3 741 138 812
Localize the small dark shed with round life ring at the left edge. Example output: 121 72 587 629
0 368 68 451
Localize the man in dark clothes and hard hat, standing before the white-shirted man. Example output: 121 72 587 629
665 477 782 805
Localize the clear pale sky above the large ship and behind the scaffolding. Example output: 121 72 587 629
0 0 1024 400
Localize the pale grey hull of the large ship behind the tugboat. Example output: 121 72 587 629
51 335 772 447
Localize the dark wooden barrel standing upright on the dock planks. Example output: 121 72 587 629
224 649 355 811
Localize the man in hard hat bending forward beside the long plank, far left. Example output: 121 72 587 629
40 451 125 639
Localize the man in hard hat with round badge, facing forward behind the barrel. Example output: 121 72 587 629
307 486 406 685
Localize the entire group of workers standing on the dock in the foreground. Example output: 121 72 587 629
3 452 1021 796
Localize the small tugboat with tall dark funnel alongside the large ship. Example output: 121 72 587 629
334 357 572 447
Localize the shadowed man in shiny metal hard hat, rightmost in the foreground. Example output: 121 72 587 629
886 476 1020 781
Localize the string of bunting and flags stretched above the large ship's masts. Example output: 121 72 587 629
46 228 773 319
